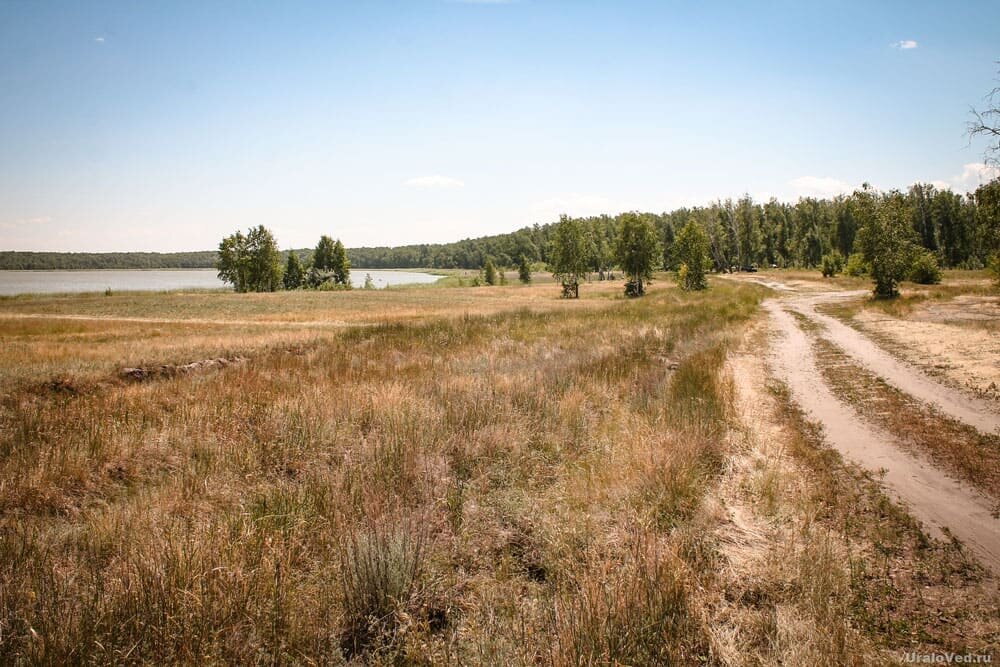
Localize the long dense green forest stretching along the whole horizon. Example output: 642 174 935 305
0 179 1000 271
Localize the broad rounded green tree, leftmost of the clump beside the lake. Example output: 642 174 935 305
216 225 281 292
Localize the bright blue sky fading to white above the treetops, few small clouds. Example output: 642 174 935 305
0 0 1000 252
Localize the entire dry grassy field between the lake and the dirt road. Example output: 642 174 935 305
0 281 995 665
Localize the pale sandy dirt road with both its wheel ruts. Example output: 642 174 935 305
748 285 1000 574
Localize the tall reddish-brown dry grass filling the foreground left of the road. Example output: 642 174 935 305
0 286 762 665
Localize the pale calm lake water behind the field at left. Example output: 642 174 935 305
0 269 440 296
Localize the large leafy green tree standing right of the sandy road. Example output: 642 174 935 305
855 191 916 299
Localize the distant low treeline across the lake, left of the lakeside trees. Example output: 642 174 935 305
0 250 218 271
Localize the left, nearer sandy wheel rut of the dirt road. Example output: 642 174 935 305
765 299 1000 574
